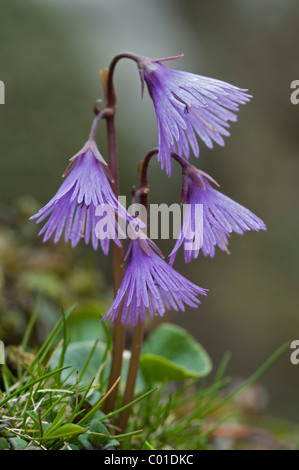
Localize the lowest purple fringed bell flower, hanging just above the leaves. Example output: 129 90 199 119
103 239 207 326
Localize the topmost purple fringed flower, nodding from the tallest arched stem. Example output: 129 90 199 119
138 57 251 176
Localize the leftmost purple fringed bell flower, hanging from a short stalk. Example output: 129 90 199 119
31 141 126 254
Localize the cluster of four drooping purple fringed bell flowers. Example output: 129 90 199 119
32 54 266 325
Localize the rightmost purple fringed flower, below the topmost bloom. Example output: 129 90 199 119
169 171 266 265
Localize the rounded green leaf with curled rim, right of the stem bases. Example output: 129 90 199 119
140 323 212 382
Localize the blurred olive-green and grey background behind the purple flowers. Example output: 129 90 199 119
0 0 299 422
